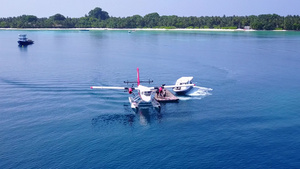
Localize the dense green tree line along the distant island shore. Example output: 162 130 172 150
0 7 300 31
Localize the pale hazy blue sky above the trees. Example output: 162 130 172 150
0 0 300 18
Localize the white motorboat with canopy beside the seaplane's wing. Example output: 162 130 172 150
173 77 194 94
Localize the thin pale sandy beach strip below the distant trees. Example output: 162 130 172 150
0 28 287 32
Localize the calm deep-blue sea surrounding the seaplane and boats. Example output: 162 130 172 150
0 31 300 168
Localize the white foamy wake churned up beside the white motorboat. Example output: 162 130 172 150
177 86 213 100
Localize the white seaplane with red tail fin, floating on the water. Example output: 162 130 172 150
91 68 195 110
